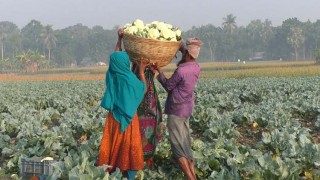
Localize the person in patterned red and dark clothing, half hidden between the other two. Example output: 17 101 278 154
132 64 164 167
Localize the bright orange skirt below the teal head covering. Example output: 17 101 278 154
98 112 144 172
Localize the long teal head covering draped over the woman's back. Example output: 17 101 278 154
101 51 146 132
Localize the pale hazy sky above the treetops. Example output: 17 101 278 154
0 0 320 30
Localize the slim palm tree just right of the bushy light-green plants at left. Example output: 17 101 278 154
41 25 57 62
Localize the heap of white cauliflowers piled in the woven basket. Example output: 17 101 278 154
124 19 181 41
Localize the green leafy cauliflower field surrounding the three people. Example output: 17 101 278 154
0 76 320 180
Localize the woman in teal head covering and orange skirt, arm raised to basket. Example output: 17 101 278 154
98 29 146 179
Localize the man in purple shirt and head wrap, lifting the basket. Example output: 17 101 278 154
151 38 202 180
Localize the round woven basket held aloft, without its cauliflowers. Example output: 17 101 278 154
123 33 181 67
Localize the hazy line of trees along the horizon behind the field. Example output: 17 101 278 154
0 14 320 72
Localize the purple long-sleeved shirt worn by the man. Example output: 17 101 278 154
157 62 200 118
